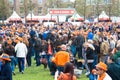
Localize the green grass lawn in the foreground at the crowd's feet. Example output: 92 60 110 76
13 59 88 80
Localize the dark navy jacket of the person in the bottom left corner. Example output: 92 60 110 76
0 62 12 80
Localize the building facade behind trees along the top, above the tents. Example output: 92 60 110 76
6 0 120 17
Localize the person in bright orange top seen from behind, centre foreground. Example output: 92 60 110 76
52 44 70 73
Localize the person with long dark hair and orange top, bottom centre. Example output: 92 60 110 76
58 62 77 80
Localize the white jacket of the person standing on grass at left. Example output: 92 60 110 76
15 42 28 58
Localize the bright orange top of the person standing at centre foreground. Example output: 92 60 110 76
53 51 70 66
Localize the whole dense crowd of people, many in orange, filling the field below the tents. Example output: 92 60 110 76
0 22 120 80
